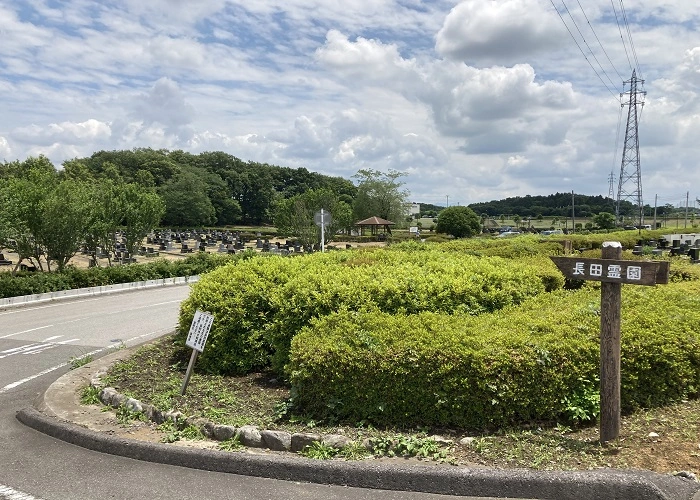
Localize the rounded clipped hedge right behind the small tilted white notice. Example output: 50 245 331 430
180 245 564 374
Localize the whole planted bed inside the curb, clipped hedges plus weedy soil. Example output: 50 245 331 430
95 233 700 472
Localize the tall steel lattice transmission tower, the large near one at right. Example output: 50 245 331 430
615 70 646 225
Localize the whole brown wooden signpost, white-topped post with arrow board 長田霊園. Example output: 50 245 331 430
550 241 669 443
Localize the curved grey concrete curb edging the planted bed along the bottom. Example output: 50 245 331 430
17 408 700 500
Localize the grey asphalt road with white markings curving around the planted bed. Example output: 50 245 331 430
0 286 508 500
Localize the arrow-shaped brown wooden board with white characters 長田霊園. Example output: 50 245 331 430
550 257 669 285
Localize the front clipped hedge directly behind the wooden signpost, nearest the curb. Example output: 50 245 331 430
288 281 700 429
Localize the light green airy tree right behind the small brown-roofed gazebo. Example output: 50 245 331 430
353 169 410 222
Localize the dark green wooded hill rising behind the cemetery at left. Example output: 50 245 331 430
63 148 357 227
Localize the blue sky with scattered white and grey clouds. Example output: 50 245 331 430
0 0 700 206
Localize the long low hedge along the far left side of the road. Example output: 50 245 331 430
0 253 250 298
